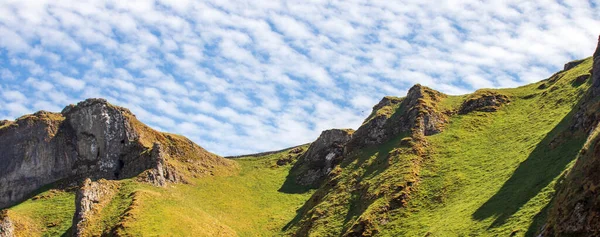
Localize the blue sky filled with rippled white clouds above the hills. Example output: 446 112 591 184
0 0 600 155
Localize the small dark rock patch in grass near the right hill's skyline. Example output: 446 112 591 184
458 90 510 114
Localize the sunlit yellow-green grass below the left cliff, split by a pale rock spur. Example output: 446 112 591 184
10 147 310 236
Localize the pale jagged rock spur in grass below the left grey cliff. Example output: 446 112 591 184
71 178 118 236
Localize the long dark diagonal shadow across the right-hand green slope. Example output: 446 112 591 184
472 106 585 228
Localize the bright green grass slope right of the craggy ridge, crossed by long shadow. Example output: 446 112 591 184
383 59 591 236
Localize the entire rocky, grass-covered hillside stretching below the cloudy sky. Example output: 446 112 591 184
0 38 600 236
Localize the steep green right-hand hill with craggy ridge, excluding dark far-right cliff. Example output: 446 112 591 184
287 50 592 236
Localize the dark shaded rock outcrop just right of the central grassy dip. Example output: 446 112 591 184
292 129 353 187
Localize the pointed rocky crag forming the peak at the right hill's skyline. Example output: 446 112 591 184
348 84 448 150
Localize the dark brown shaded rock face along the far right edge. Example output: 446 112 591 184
540 34 600 236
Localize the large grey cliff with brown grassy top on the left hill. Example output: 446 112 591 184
0 99 235 208
